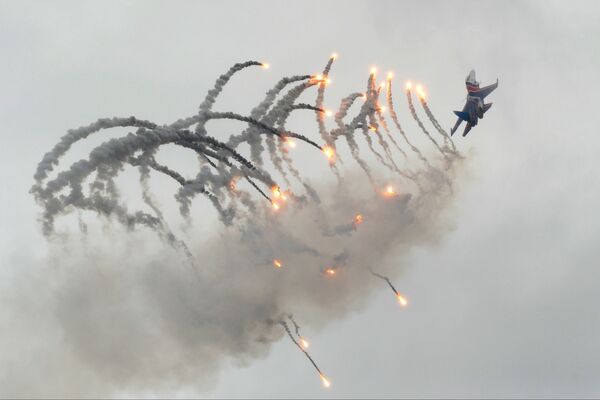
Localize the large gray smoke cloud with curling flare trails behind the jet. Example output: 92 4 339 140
7 56 464 397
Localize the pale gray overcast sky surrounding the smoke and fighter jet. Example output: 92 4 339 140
0 1 600 397
